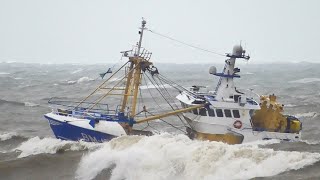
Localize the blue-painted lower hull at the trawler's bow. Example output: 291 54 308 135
45 116 116 142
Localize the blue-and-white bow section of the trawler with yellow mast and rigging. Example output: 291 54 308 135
44 20 205 142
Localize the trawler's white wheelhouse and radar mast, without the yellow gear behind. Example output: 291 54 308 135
177 46 300 144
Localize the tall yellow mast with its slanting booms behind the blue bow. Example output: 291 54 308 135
77 20 206 127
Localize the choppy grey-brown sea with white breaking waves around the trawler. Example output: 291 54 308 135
0 62 320 180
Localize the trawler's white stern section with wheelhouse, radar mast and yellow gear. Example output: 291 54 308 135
176 46 302 144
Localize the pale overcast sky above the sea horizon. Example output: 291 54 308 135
0 0 320 63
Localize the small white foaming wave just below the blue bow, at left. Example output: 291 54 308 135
13 137 102 158
